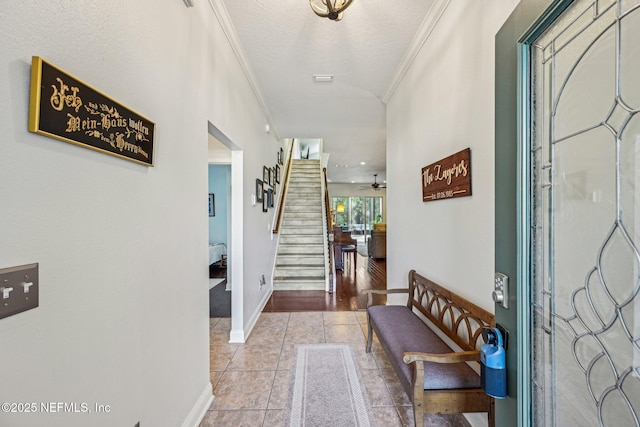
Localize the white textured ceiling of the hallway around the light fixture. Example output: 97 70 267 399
223 0 433 184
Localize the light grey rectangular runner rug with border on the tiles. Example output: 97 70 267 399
285 344 375 427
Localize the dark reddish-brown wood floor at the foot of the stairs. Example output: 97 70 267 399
263 254 387 312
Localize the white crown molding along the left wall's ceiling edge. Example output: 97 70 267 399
208 0 281 141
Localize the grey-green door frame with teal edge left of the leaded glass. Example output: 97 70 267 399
494 0 573 427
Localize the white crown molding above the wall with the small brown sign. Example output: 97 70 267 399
382 0 451 104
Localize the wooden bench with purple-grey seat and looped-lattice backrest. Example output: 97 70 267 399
365 270 495 427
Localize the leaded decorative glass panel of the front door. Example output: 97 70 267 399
529 0 640 427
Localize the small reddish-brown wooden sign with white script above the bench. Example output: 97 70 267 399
422 148 471 202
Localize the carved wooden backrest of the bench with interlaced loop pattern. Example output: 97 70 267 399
407 270 495 350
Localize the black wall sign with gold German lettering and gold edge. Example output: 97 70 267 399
29 56 155 166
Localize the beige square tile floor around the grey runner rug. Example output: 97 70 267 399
200 311 476 427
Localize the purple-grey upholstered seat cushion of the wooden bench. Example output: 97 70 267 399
367 305 480 397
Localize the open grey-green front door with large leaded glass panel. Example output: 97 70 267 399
496 0 640 427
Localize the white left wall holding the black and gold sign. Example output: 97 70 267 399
0 0 279 427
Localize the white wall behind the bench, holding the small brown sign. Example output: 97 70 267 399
387 0 517 312
